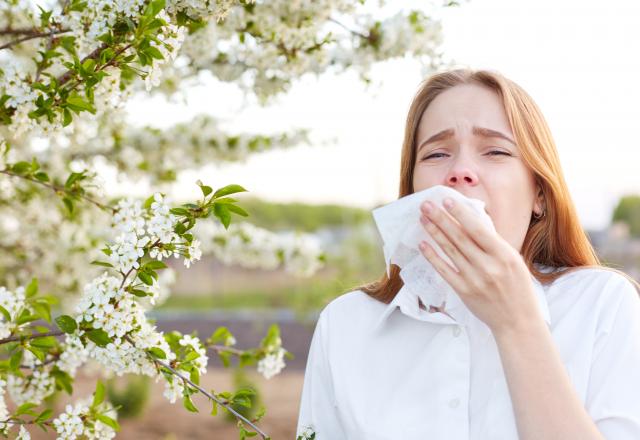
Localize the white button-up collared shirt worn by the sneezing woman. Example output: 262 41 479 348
296 265 640 440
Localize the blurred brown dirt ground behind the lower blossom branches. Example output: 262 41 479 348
29 368 304 440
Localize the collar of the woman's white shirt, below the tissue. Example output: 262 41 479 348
373 263 551 330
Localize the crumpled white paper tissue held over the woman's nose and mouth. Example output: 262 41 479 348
372 185 497 322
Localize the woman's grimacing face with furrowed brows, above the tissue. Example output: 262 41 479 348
413 84 543 252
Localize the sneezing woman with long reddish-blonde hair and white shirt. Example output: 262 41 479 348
297 69 640 440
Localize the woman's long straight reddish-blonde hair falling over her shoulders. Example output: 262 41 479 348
350 69 640 303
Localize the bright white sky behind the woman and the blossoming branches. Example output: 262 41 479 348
128 0 640 229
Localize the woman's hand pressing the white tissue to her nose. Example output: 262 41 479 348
420 199 543 335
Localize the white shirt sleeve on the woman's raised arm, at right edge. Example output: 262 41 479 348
585 276 640 440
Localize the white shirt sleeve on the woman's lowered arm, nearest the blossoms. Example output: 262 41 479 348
296 308 347 440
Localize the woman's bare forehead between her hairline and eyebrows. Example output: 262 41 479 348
417 84 513 142
